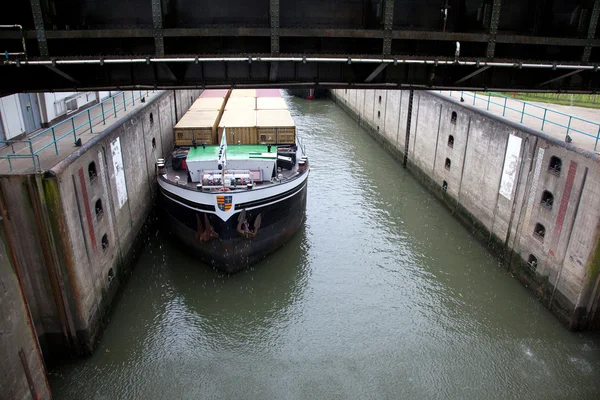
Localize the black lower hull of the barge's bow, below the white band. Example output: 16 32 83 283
159 181 307 273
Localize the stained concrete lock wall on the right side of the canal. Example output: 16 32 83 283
331 89 600 330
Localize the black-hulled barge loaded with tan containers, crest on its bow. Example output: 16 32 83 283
157 89 310 273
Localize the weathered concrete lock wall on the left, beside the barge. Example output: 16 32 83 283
0 90 201 376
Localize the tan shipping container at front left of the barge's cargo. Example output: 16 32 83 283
173 110 219 146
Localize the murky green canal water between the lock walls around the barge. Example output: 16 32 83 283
50 97 600 400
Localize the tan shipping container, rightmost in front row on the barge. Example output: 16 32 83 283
256 110 296 144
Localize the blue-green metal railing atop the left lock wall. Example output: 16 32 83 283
0 90 155 171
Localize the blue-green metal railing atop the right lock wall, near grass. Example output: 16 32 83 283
439 90 600 151
